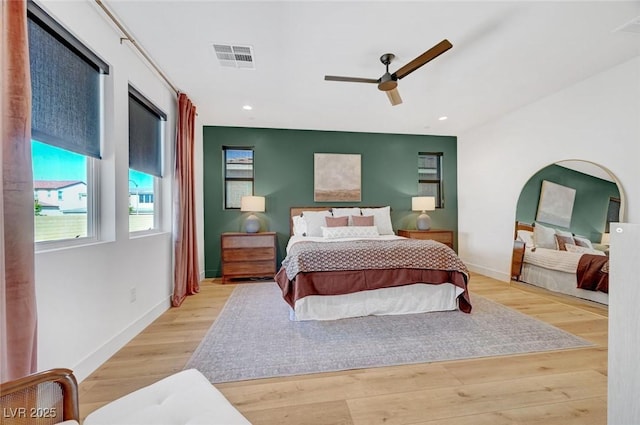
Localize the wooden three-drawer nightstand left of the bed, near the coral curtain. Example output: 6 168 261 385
221 232 277 283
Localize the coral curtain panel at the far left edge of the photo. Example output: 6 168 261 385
0 0 37 382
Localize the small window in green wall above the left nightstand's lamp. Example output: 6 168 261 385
222 146 254 209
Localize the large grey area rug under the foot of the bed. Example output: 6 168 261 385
186 283 593 383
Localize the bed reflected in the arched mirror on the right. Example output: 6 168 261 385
514 223 609 305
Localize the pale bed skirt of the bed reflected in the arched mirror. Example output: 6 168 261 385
520 263 609 305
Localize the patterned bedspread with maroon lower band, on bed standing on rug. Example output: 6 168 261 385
275 239 471 313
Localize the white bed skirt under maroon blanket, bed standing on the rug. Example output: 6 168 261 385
290 283 463 320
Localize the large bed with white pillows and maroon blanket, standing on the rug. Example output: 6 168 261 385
275 207 471 320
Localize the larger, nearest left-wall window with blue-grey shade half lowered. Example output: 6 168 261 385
27 1 109 243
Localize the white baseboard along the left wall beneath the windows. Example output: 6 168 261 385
73 298 171 382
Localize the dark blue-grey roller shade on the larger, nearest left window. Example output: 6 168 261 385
28 2 109 158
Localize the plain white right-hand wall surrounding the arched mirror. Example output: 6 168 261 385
458 57 640 281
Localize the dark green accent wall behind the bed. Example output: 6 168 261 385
203 126 458 277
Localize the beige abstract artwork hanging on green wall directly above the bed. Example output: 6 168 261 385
313 153 362 202
